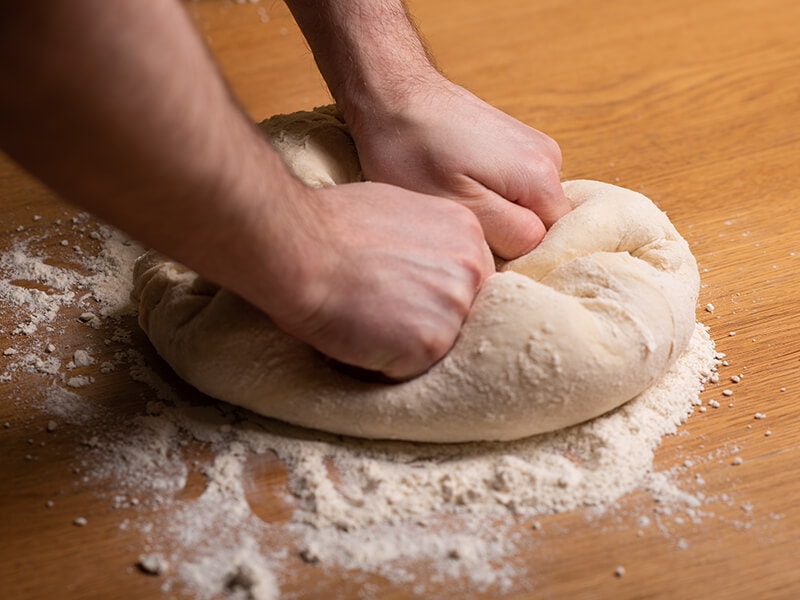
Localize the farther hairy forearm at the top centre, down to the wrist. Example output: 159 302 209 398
286 0 441 126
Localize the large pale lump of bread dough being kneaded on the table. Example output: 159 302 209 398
128 109 699 442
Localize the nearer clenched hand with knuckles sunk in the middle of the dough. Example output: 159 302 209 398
271 183 494 379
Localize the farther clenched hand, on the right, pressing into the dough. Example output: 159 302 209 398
349 74 570 259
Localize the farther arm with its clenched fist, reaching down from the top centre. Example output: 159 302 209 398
287 0 569 258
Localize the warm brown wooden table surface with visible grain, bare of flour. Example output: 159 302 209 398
0 0 800 598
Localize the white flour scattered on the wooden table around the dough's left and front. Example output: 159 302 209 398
0 217 730 600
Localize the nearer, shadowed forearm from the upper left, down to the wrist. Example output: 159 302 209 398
0 0 310 310
